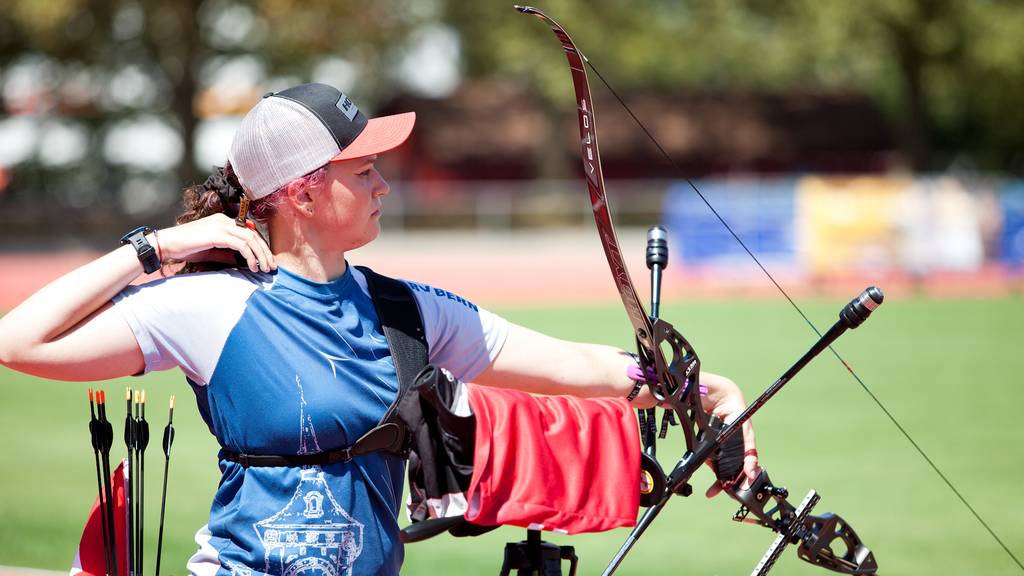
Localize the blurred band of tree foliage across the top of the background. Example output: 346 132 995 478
0 0 1024 235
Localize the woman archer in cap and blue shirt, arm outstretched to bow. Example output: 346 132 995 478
0 84 758 575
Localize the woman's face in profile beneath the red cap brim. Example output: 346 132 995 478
313 155 390 250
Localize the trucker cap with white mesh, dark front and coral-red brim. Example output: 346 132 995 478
227 84 416 200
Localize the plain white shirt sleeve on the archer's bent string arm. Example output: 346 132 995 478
112 271 259 384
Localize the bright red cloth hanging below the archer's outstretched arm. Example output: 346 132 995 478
466 384 640 534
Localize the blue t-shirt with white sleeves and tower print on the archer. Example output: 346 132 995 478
115 266 508 575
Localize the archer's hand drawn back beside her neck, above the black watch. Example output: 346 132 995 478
156 213 278 272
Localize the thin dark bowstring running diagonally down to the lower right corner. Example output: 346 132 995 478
584 57 1024 572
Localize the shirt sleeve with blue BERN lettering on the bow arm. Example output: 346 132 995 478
406 281 509 382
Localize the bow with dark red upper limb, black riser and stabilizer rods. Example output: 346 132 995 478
516 6 883 575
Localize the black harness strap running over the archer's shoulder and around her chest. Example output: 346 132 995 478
220 266 429 467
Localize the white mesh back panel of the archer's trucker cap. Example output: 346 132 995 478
227 96 339 200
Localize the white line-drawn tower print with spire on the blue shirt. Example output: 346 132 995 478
253 374 364 576
